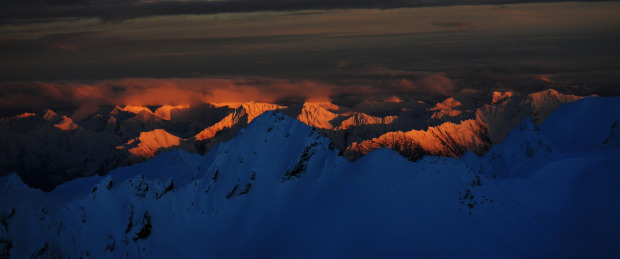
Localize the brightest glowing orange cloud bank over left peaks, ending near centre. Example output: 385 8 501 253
0 78 335 109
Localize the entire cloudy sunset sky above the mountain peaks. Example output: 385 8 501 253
0 0 620 113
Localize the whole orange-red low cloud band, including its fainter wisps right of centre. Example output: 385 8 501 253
0 74 456 113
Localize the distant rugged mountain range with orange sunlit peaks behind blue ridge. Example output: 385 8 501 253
0 90 581 190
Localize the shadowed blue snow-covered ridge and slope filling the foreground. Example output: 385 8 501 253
0 98 620 258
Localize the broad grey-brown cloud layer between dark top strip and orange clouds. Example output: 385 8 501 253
0 1 620 85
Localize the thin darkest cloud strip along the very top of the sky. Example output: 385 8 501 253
0 0 604 21
